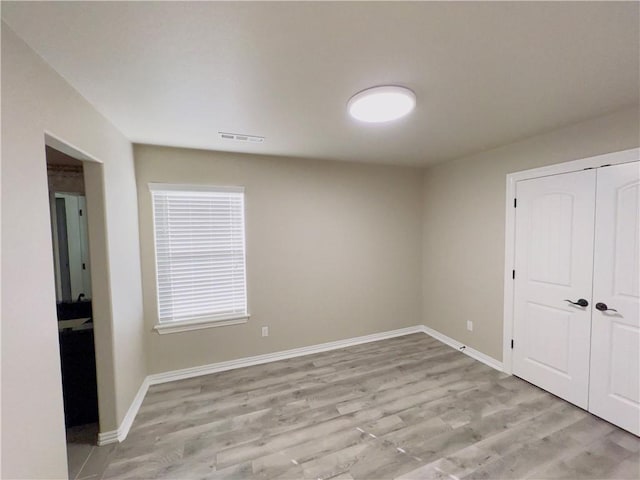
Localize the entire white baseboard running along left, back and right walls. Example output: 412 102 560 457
98 325 502 445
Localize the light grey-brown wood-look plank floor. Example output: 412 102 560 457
90 334 640 480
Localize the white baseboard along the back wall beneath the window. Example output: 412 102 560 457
147 325 423 385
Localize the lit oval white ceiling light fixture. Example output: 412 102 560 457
347 85 416 123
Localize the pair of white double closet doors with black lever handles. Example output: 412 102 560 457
511 157 640 435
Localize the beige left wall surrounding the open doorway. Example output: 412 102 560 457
1 23 146 479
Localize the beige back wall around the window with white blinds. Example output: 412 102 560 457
134 145 422 373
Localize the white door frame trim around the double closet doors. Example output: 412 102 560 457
502 148 640 374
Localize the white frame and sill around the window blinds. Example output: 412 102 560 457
148 183 251 334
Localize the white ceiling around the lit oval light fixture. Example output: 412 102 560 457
2 1 640 165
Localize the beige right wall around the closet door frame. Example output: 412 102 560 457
423 107 640 360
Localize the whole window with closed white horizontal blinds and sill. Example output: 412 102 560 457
149 184 249 333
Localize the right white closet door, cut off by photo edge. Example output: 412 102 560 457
589 162 640 435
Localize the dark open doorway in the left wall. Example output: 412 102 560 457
45 145 99 478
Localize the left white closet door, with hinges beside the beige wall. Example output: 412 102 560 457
513 170 596 408
